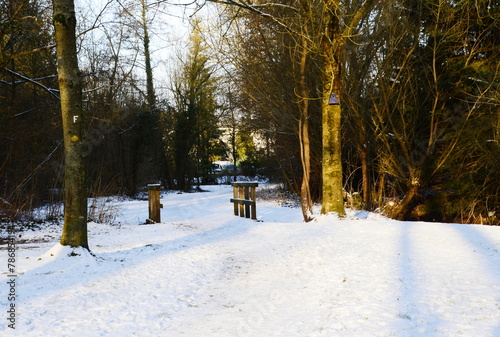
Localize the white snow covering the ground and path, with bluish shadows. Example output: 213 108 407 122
0 186 500 337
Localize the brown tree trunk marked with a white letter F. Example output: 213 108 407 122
53 0 89 249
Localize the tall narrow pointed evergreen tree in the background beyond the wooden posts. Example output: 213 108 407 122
173 24 218 190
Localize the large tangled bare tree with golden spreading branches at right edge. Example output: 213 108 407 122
372 1 499 220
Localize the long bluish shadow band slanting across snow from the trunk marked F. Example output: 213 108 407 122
18 217 262 301
